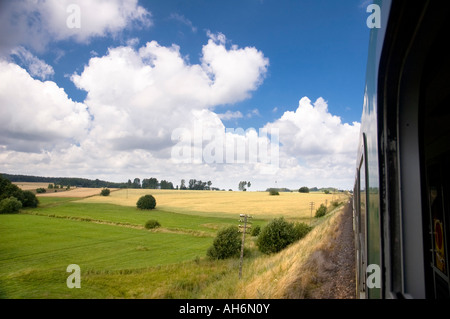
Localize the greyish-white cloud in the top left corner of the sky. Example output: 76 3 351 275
0 0 152 56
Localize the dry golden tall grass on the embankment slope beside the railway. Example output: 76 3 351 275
196 210 342 299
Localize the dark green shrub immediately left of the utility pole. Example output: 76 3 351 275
206 226 241 259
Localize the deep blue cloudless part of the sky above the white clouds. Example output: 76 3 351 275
53 0 369 127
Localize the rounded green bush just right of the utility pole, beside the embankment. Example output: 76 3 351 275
256 217 311 254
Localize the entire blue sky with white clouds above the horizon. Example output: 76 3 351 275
0 0 370 191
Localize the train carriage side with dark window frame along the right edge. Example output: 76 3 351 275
353 0 450 298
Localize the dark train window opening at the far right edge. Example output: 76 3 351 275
421 16 450 298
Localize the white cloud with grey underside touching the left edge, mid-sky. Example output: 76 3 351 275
0 60 89 153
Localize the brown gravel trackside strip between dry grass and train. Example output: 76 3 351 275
308 204 355 299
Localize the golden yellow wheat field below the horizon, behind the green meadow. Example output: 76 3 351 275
78 189 348 219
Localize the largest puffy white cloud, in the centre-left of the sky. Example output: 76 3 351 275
72 33 268 157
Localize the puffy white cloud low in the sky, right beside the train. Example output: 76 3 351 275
265 97 360 187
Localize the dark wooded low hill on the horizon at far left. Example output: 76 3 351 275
0 173 127 188
